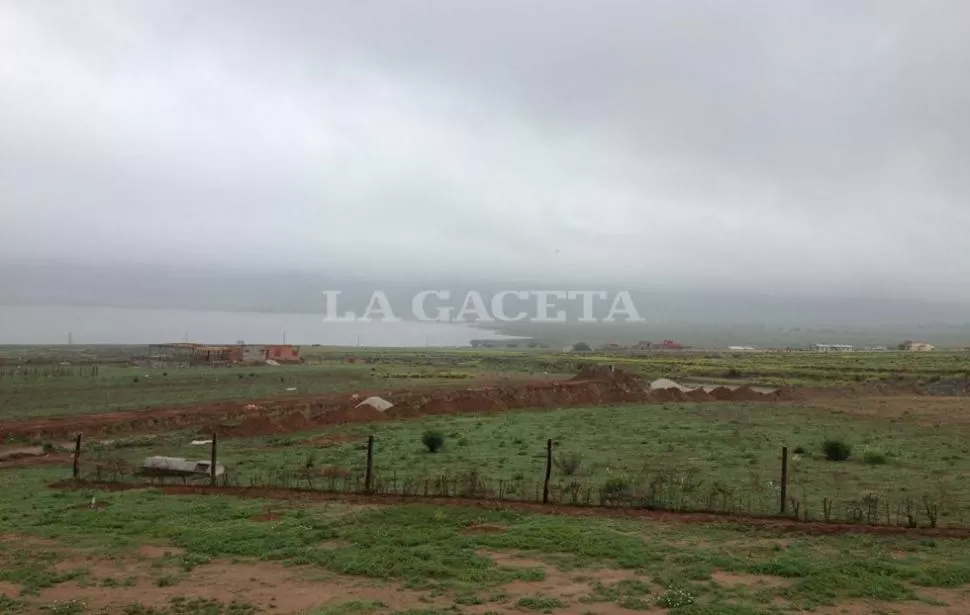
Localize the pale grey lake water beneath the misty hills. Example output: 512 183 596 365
0 305 513 347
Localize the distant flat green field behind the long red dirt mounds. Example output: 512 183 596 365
0 346 970 420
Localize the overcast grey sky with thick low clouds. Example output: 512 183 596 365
0 0 970 298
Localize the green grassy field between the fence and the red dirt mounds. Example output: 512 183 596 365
73 402 970 526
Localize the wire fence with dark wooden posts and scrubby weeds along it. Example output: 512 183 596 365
72 435 948 528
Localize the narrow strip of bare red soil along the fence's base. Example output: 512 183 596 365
48 479 970 539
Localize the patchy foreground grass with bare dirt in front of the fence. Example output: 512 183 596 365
0 470 970 615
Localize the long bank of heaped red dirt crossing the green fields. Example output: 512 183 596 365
0 368 795 440
